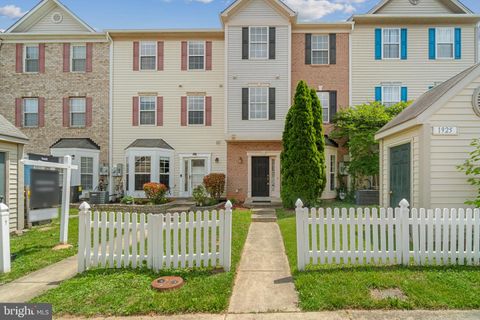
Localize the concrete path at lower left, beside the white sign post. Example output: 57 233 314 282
0 256 77 303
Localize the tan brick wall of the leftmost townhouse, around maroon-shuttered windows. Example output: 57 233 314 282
0 42 109 163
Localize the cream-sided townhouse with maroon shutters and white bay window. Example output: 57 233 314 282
109 30 227 197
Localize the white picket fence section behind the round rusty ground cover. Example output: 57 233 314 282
78 201 232 272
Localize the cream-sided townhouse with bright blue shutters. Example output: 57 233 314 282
351 0 480 105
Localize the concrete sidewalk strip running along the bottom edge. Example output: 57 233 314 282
55 310 480 320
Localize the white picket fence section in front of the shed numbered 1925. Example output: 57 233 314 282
296 200 480 270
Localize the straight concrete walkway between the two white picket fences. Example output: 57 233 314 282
228 215 298 313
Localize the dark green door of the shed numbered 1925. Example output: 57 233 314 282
390 143 411 207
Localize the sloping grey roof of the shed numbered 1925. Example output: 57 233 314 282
377 64 480 135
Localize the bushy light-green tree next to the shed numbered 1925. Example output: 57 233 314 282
330 102 409 189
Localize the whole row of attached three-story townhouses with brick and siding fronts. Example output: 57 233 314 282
0 0 480 218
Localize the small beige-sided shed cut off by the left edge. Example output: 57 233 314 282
0 115 28 231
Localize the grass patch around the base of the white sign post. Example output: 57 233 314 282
0 209 78 285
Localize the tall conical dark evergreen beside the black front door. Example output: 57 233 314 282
281 81 325 208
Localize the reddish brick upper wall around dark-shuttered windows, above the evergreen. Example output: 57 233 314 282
292 33 349 133
